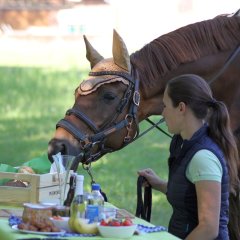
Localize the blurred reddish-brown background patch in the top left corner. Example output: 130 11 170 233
0 0 105 30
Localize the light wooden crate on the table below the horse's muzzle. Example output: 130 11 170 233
0 172 70 205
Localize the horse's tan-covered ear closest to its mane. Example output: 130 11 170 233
112 29 131 72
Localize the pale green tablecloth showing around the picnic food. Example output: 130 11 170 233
0 202 179 240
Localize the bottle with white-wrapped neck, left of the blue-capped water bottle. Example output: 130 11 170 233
70 175 86 218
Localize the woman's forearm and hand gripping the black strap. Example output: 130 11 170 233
138 168 167 194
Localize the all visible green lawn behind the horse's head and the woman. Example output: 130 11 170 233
0 66 171 226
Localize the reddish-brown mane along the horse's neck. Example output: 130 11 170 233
130 16 240 94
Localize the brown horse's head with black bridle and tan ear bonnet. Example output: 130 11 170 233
48 31 140 168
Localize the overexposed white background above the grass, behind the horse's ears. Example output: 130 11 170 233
0 0 240 68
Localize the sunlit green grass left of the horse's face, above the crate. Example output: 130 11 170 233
0 67 85 164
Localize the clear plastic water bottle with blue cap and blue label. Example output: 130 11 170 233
86 183 104 223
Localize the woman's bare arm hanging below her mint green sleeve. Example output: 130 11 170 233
186 180 221 240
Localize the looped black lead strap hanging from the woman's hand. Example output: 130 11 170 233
135 176 152 222
